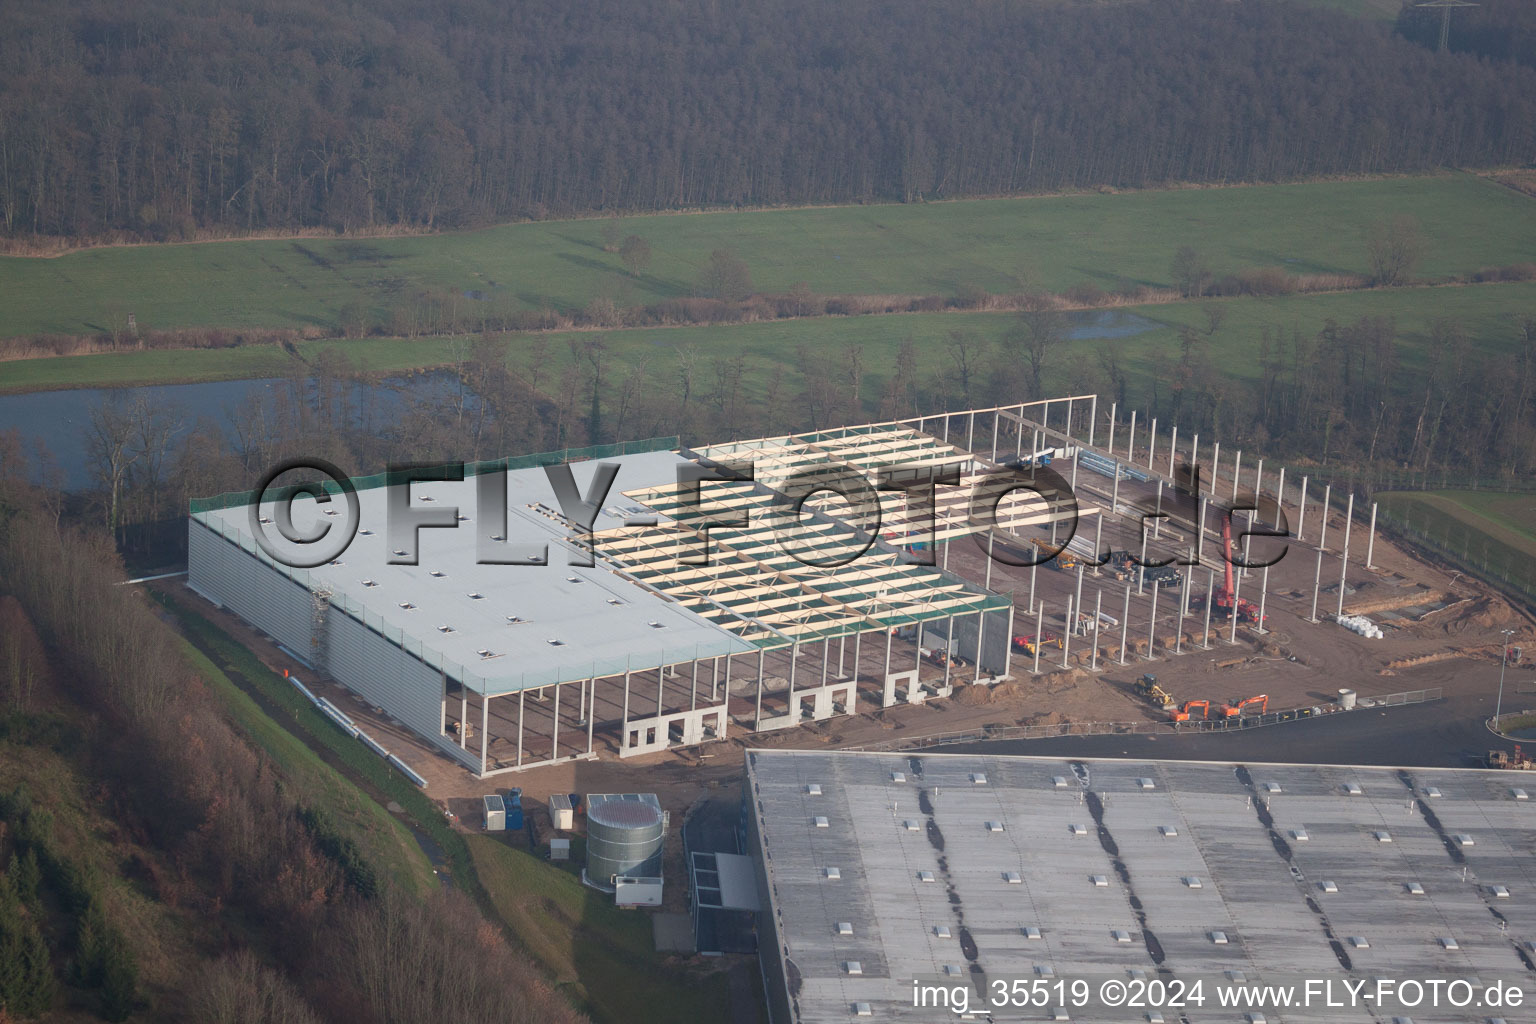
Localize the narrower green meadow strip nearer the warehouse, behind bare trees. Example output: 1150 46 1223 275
0 282 1536 398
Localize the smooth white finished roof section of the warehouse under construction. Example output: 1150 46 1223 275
194 451 757 695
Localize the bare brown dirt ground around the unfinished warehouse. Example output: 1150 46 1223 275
158 448 1536 906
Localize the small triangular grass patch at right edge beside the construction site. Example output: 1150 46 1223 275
1376 491 1536 593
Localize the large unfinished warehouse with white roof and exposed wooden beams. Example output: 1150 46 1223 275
189 396 1388 777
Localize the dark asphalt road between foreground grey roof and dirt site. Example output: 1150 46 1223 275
935 687 1517 768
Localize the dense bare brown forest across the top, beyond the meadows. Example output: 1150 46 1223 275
0 0 1536 239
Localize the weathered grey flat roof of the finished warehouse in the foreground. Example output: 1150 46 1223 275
746 751 1536 1024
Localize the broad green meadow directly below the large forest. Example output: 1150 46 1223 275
0 173 1536 336
